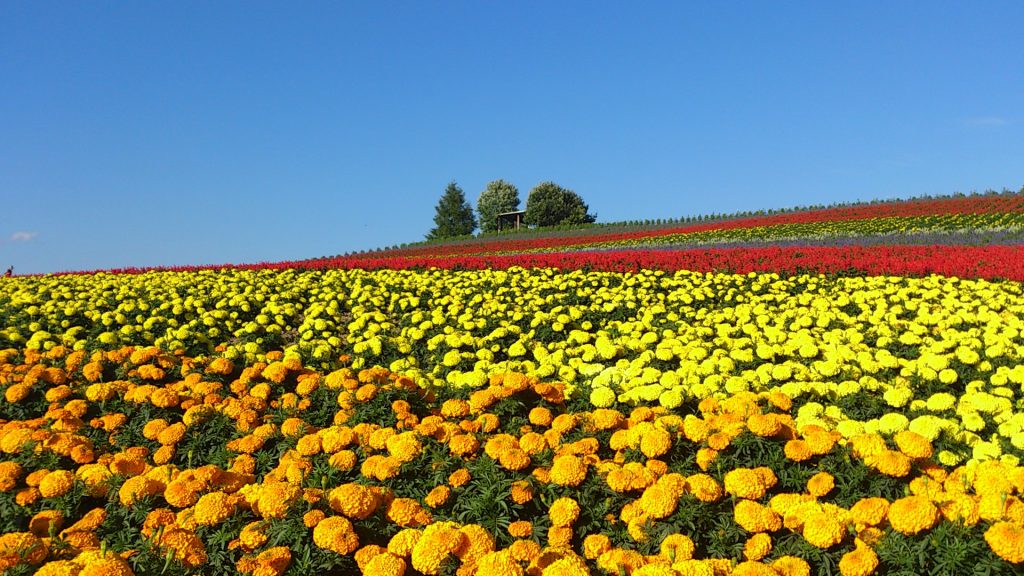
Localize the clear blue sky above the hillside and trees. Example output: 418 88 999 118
0 0 1024 274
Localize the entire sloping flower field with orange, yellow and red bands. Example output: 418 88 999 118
0 190 1024 576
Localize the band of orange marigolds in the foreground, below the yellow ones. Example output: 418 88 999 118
0 346 1024 576
